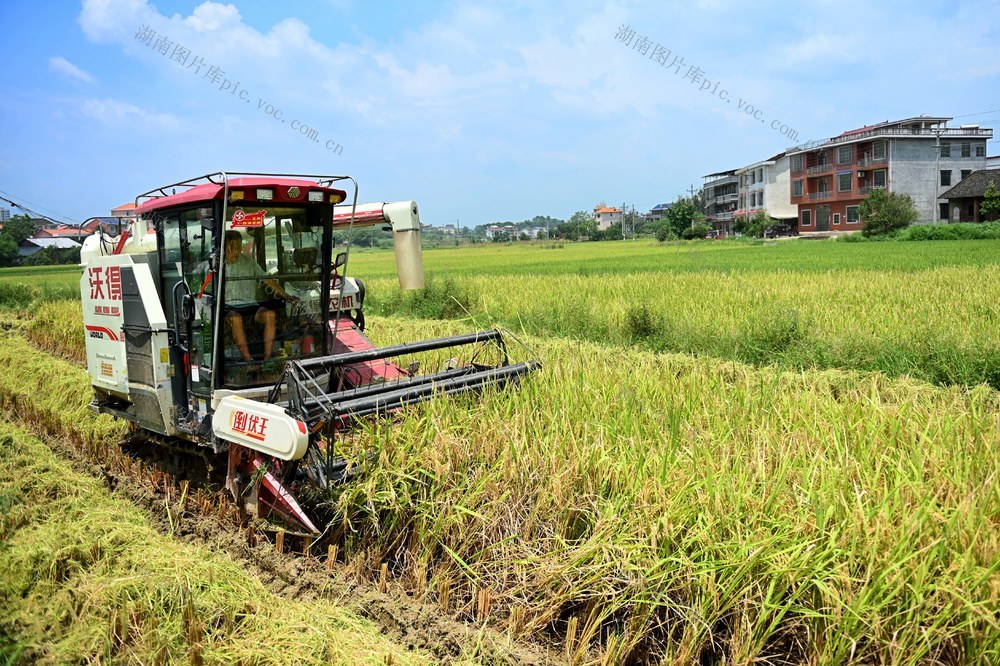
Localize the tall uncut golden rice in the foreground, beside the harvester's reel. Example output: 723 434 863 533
330 319 1000 663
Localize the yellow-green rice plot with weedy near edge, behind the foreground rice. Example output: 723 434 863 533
368 260 1000 388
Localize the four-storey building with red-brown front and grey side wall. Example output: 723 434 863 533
787 116 993 233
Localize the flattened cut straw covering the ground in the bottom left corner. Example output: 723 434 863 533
0 421 430 664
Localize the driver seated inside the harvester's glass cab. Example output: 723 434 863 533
225 230 299 361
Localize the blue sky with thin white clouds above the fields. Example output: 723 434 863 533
0 0 1000 226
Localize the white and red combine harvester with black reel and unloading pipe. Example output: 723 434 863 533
80 172 539 533
